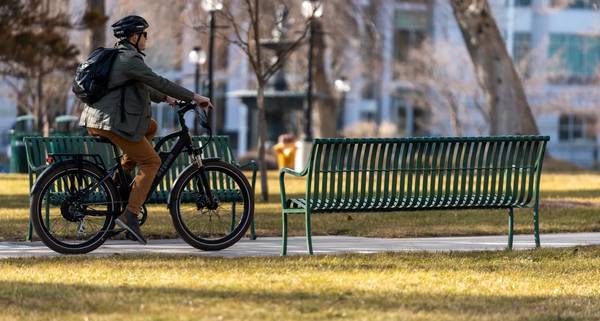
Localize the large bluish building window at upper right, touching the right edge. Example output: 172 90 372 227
549 34 600 84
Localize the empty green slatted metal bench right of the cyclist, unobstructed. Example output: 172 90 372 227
280 136 549 255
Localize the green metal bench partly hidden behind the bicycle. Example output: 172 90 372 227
23 136 257 240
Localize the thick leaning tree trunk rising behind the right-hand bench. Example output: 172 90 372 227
451 0 539 135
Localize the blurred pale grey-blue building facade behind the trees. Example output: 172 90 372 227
0 0 600 167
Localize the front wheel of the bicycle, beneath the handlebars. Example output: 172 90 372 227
169 160 254 251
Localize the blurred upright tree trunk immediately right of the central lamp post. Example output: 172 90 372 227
312 20 339 137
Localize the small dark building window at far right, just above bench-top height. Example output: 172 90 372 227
558 114 596 142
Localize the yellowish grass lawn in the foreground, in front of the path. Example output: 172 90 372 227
0 247 600 321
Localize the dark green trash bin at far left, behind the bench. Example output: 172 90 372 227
9 115 40 173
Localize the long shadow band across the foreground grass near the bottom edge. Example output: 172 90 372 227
0 281 600 320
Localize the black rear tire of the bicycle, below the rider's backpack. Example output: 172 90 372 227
30 161 120 254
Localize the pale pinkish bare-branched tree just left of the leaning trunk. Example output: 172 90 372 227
395 40 489 136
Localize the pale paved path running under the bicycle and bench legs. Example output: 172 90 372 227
0 233 600 258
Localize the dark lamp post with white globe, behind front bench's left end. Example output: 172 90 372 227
302 0 323 142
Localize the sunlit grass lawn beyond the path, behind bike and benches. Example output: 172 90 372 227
0 172 600 240
